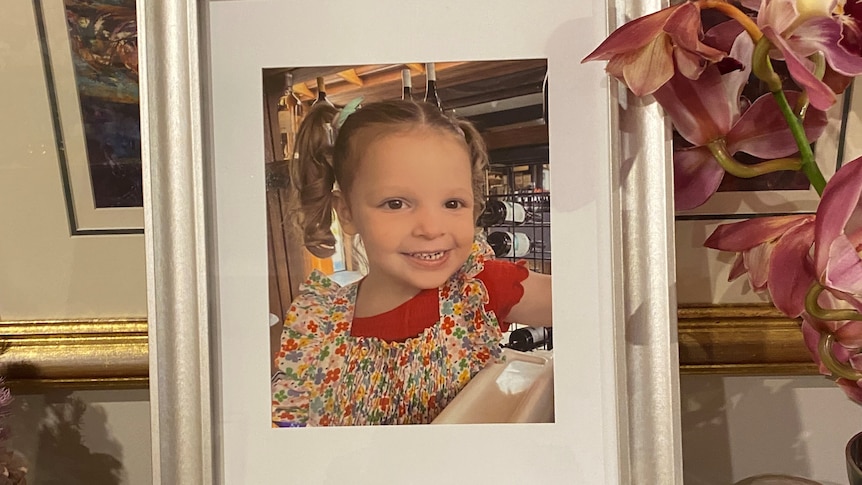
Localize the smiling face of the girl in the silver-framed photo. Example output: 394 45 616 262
336 128 474 304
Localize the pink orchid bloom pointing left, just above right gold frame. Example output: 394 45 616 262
704 214 815 317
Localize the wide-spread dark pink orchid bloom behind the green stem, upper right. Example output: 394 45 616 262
653 29 827 210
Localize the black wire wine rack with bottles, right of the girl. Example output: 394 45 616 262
479 157 553 350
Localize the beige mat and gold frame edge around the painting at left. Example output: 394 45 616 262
0 1 148 387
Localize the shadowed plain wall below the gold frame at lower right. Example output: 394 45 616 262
681 376 862 485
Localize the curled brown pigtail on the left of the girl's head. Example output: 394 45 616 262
288 103 338 258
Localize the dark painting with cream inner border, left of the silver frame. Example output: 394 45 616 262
33 0 143 235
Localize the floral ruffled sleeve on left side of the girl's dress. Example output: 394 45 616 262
272 271 340 427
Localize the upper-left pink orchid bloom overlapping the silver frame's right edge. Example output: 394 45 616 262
581 2 726 96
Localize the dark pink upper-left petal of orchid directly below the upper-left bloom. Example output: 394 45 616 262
653 66 735 146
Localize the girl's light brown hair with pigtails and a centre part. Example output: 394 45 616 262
289 100 488 258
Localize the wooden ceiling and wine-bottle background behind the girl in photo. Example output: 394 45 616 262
262 59 553 376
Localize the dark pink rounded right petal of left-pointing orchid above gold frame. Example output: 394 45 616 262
769 222 815 318
